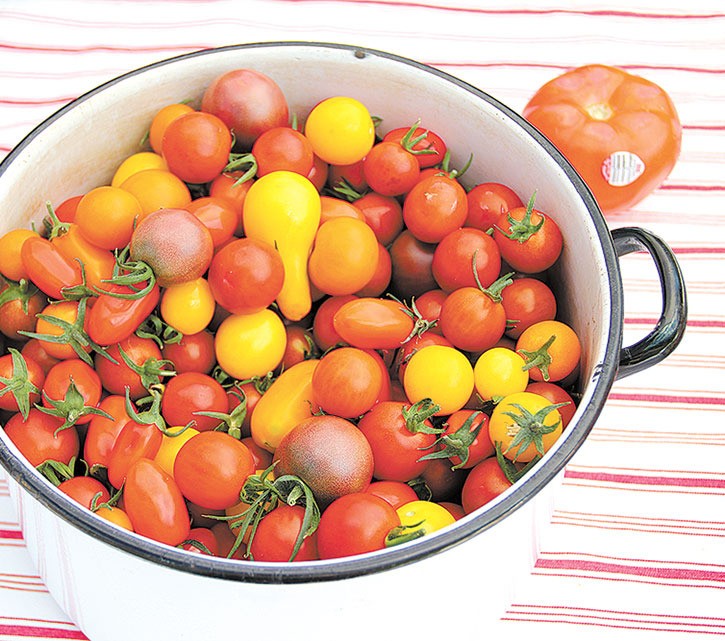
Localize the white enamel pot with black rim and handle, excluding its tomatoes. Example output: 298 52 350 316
0 42 686 641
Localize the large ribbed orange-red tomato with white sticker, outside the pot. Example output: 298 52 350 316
523 65 682 214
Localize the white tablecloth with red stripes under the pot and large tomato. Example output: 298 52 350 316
0 0 725 641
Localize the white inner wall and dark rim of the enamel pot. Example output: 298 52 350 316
0 42 622 583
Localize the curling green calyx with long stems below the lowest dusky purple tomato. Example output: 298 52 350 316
221 464 320 561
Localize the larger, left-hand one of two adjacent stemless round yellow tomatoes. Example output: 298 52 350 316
403 345 473 416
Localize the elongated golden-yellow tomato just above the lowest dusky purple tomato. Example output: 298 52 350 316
251 359 319 452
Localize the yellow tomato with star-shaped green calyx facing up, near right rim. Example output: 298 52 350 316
488 392 562 463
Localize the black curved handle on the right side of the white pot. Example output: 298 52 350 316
612 227 687 378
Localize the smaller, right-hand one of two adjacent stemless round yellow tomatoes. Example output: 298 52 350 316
473 347 529 401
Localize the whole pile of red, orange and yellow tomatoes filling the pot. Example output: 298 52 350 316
0 69 581 562
